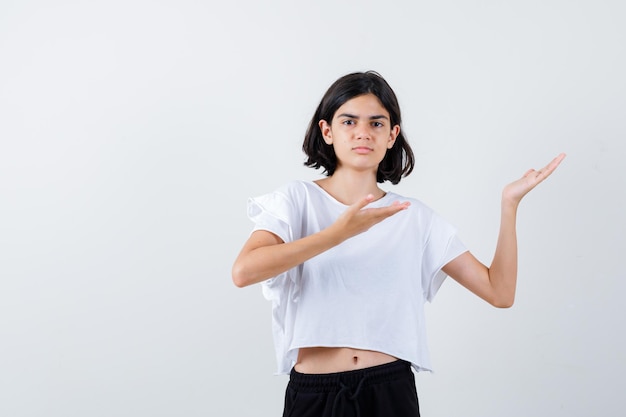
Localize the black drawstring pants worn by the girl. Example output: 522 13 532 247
283 360 420 417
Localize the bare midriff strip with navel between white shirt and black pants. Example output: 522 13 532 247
295 347 398 374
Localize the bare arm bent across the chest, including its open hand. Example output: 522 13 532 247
232 195 409 287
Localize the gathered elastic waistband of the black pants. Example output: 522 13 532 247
289 359 414 392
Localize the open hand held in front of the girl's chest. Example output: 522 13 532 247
331 194 411 240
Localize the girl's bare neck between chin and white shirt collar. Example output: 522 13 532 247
315 171 385 205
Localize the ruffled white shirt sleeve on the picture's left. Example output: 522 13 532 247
248 191 293 242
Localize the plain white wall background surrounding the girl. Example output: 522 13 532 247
0 0 626 417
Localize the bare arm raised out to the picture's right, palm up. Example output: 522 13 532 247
443 153 565 308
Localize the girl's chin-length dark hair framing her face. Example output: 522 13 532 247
302 71 415 184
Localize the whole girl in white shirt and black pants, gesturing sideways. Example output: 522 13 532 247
233 71 565 417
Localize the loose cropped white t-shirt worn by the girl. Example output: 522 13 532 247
248 181 467 374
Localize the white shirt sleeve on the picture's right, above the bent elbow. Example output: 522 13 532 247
422 215 467 302
